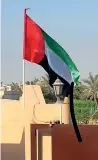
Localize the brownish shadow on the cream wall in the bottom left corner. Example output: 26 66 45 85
1 132 25 160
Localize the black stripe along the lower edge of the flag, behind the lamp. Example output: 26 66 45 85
39 55 70 97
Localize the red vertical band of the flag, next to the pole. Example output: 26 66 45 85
23 10 45 63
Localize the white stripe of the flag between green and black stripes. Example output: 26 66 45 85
45 42 72 84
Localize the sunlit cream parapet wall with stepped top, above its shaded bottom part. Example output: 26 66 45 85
1 85 59 143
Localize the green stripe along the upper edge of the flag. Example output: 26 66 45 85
42 30 80 83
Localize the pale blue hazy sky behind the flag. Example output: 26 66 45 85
1 0 98 83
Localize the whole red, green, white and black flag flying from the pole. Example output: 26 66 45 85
23 11 80 96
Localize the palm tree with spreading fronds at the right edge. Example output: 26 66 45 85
83 73 98 106
